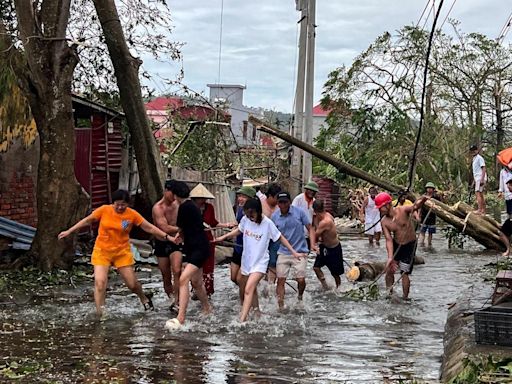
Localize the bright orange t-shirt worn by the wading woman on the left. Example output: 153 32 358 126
92 205 144 251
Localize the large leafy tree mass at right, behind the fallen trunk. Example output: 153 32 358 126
314 22 512 194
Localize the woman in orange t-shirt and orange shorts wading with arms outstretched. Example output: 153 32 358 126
58 189 170 316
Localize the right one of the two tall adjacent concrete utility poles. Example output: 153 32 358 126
302 0 316 184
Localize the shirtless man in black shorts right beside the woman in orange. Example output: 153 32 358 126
152 180 183 310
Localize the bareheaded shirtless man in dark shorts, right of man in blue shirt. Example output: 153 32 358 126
312 200 344 290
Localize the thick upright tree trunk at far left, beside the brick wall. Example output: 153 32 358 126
0 0 88 271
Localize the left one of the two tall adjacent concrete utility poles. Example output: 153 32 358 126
290 0 308 196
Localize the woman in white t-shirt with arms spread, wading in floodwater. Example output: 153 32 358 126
215 199 304 322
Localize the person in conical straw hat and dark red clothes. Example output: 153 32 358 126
190 183 237 297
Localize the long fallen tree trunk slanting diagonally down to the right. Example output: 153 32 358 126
249 116 505 251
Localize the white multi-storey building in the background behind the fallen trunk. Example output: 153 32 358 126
207 84 263 147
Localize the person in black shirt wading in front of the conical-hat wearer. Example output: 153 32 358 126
169 180 211 327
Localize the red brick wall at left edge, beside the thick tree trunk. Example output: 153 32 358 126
0 138 39 227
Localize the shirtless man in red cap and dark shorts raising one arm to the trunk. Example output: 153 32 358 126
375 192 428 300
